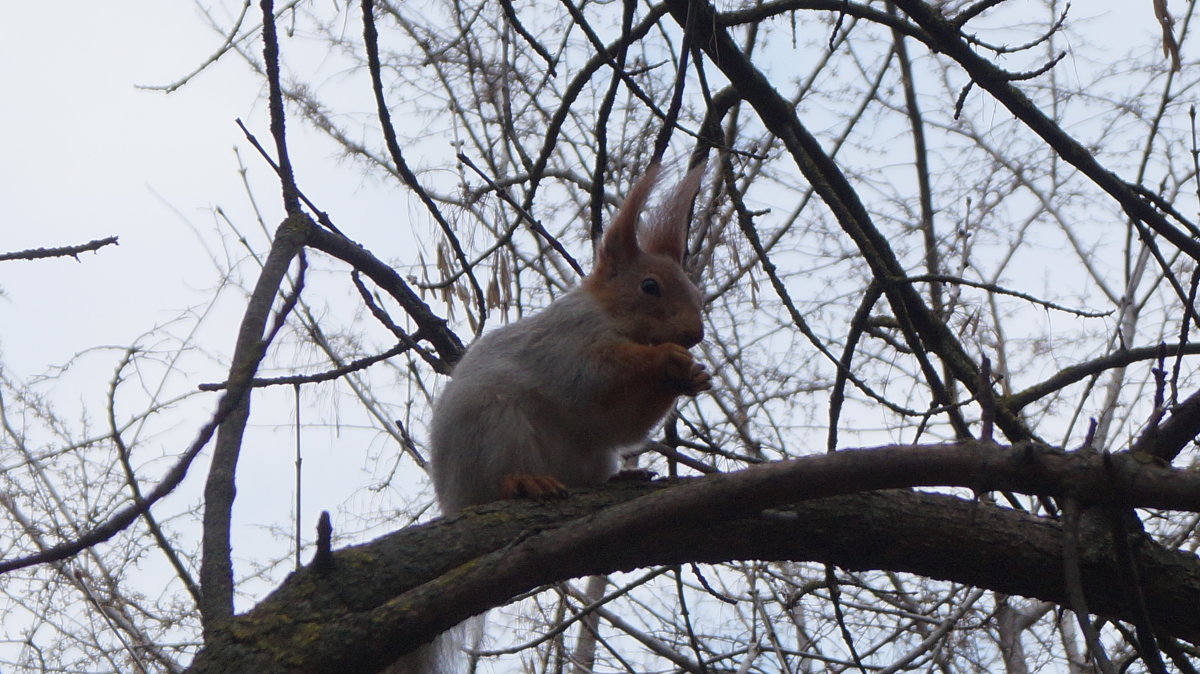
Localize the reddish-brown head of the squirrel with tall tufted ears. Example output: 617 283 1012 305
583 164 704 348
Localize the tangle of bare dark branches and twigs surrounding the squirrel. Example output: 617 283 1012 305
0 0 1200 673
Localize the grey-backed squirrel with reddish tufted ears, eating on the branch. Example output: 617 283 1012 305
386 164 712 674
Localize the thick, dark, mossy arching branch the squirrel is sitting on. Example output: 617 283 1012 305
184 443 1200 673
